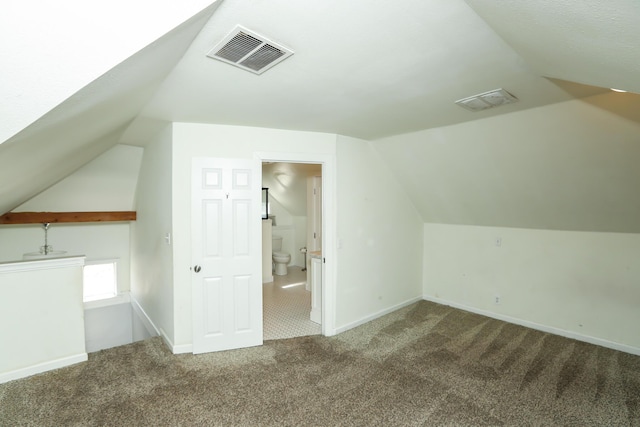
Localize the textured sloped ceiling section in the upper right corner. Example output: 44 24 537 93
467 0 640 93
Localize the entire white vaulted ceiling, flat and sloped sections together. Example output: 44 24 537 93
0 0 640 232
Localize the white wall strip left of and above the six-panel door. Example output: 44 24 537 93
173 123 336 351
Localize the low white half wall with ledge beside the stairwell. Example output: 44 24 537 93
0 257 87 383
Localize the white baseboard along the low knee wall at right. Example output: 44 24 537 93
423 296 640 356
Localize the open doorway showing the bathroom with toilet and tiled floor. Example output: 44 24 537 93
262 161 323 340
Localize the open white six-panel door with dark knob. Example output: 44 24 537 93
191 158 262 353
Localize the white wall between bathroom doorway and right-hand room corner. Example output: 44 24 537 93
336 136 422 330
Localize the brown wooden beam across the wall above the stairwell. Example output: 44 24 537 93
0 211 136 224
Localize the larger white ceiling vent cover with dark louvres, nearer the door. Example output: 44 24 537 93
207 25 293 74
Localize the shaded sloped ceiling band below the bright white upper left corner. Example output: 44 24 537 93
0 3 222 213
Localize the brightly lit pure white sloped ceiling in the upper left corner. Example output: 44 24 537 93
0 0 218 143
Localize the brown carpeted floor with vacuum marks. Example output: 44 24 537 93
0 301 640 426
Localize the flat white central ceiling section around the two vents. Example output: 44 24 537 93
132 0 603 139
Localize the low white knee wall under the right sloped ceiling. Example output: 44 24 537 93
423 224 640 354
